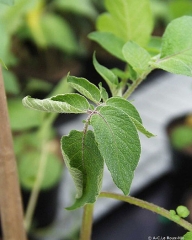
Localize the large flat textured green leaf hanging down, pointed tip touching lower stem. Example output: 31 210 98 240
90 106 141 194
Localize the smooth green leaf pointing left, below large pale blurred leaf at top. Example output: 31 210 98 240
88 32 126 61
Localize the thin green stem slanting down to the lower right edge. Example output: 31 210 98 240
99 192 192 231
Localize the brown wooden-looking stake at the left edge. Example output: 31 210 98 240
0 67 26 240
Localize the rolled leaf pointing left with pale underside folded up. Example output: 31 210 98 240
22 93 89 113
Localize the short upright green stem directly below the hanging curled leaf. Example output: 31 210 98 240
80 203 94 240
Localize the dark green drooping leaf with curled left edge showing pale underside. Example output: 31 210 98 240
61 130 104 210
